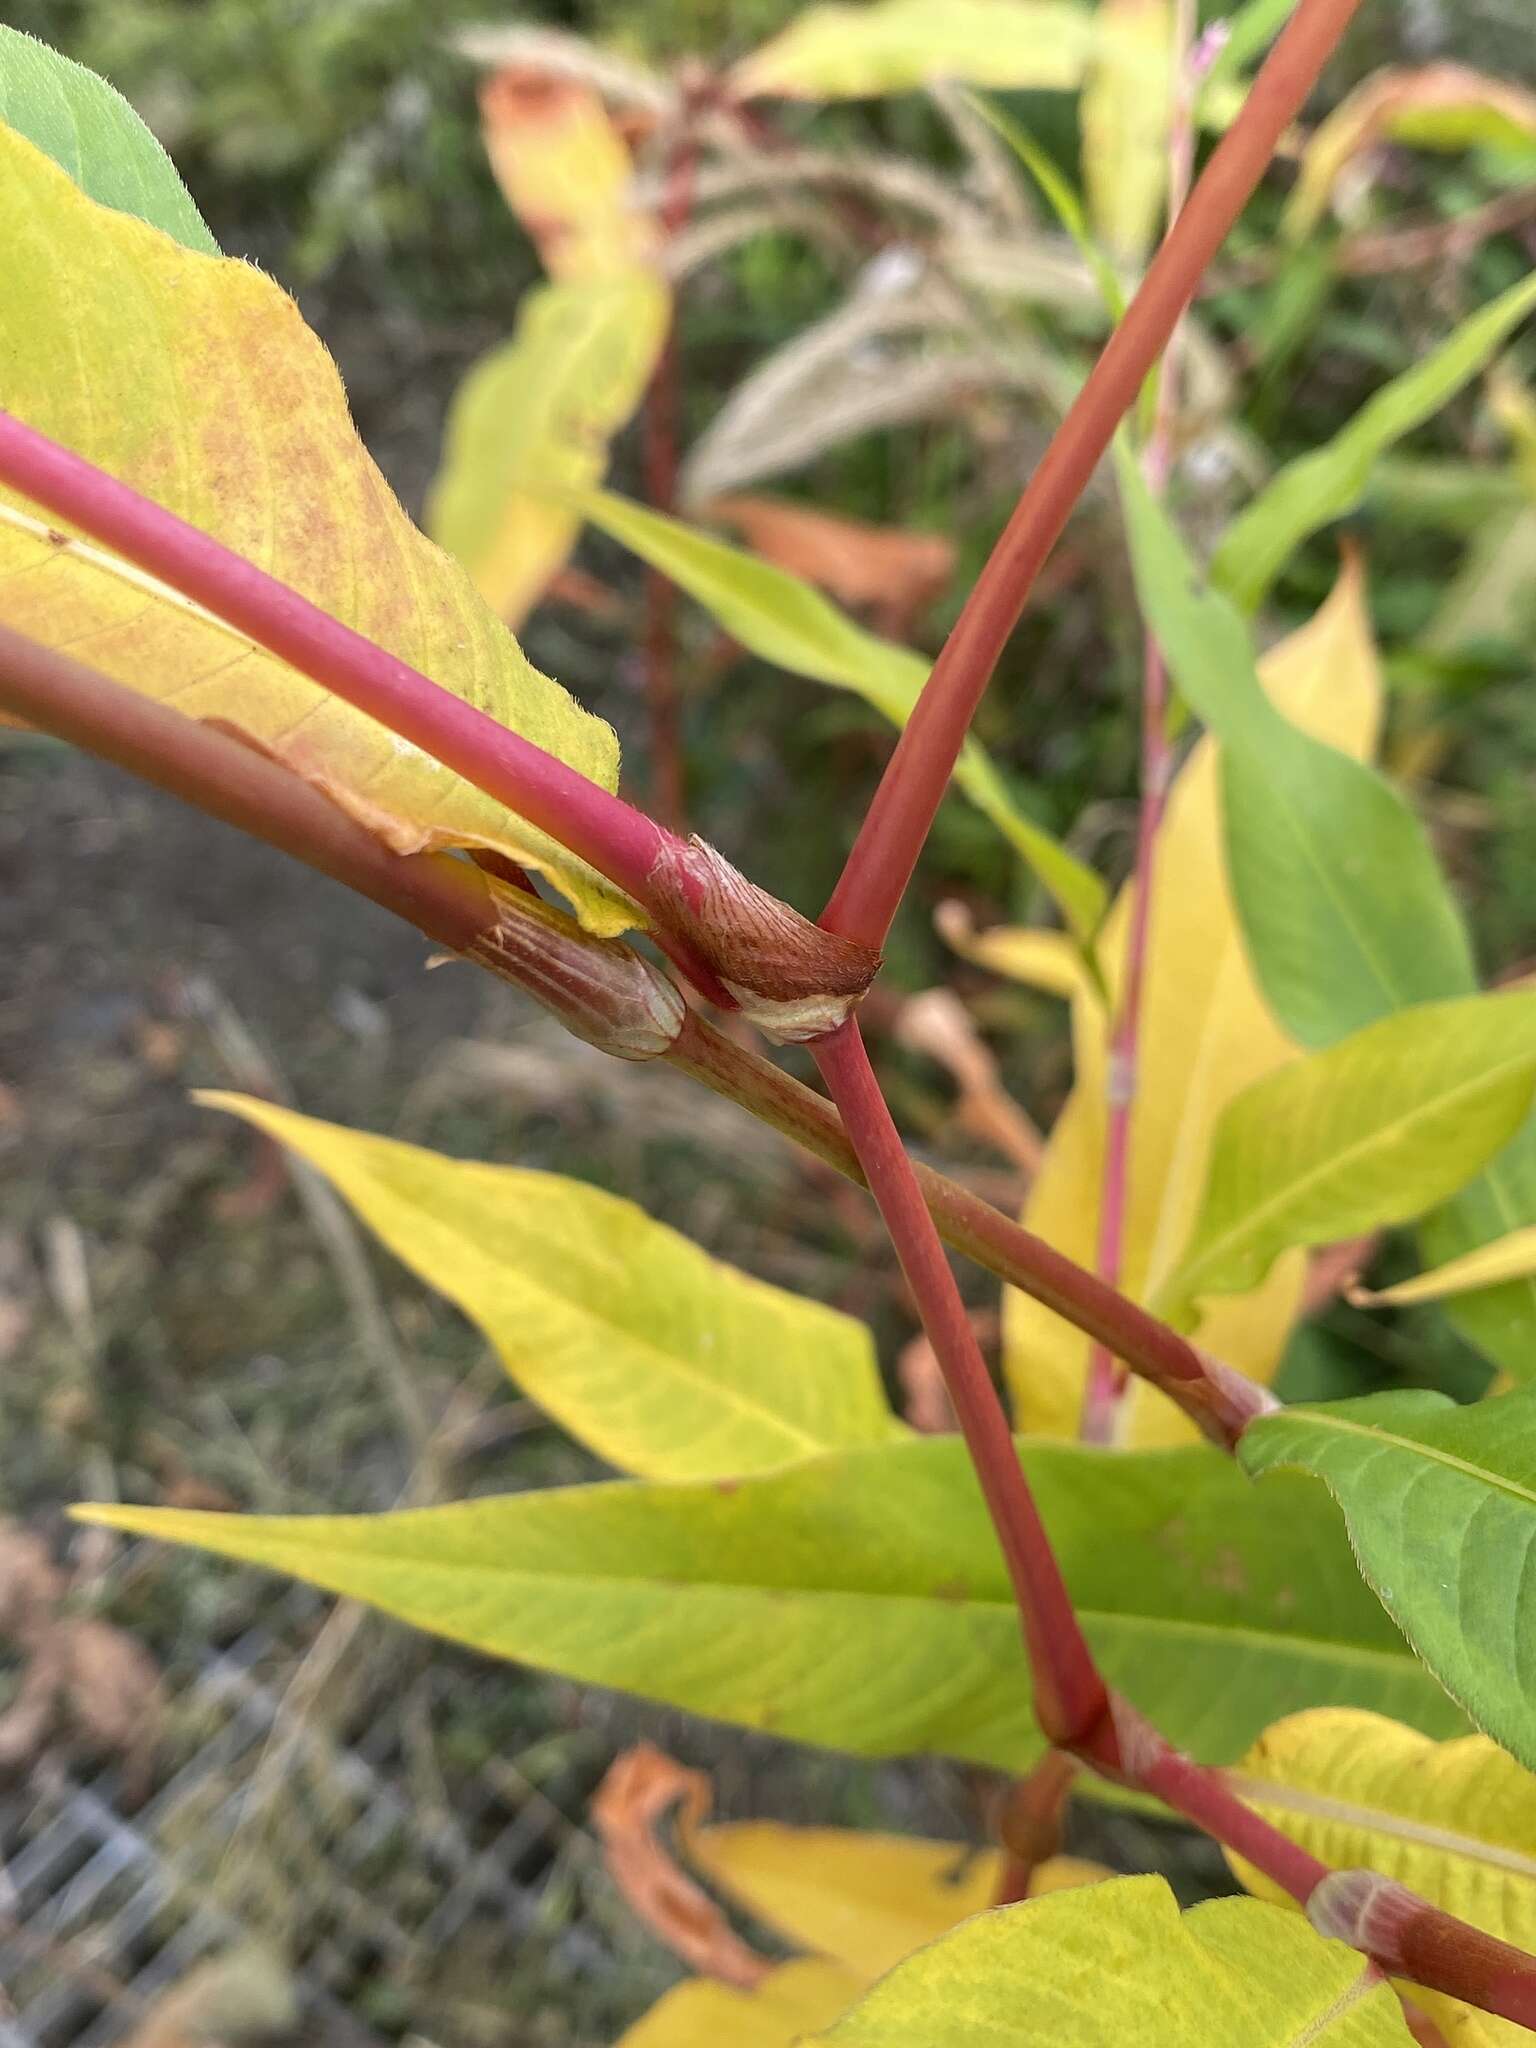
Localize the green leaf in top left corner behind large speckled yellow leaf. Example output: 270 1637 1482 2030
0 23 219 256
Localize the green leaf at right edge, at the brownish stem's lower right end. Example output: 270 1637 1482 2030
1237 1389 1536 1767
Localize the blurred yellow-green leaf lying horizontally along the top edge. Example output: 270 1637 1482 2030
731 0 1094 100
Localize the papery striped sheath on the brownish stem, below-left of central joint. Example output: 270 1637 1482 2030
465 877 686 1059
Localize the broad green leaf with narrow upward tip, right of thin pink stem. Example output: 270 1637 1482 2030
1118 446 1475 1044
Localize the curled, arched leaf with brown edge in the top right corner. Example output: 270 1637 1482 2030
1282 63 1536 240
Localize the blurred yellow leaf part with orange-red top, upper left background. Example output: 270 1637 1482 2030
479 63 657 281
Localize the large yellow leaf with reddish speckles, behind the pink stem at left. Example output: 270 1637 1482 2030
0 129 635 932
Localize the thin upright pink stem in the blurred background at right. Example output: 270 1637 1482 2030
1079 0 1198 1444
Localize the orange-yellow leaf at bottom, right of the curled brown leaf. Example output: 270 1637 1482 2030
688 1821 1112 1985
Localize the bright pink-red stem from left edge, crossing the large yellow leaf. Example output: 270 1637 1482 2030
0 412 729 1004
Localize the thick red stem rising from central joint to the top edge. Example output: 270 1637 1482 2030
821 0 1360 946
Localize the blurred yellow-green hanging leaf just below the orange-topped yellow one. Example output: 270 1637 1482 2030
426 270 672 627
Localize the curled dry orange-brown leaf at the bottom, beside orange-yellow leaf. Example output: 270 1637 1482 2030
592 1743 772 1991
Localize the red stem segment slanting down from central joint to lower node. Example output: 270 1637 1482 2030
811 1018 1108 1747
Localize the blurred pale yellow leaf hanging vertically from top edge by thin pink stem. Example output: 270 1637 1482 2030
1077 0 1174 264
